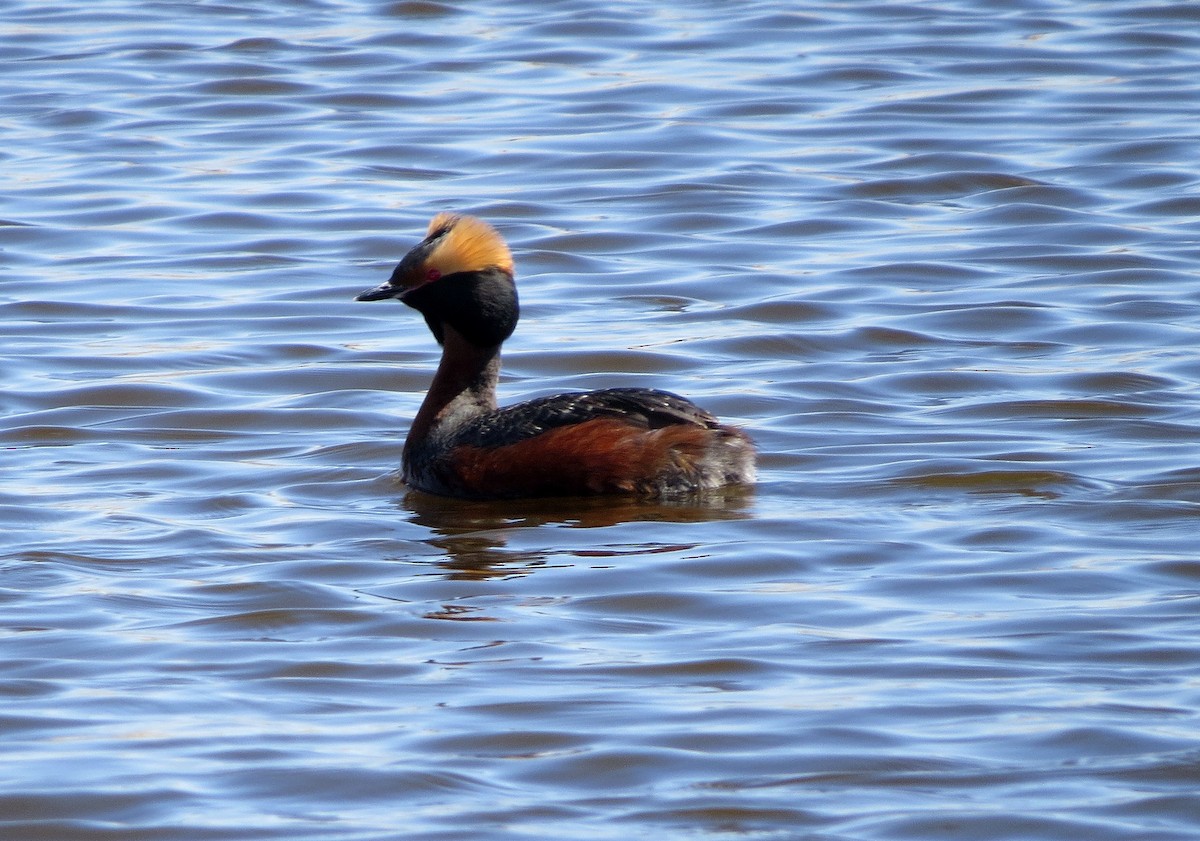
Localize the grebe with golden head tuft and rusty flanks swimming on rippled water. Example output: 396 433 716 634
355 212 756 499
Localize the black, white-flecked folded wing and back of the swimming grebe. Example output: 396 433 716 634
455 389 718 447
